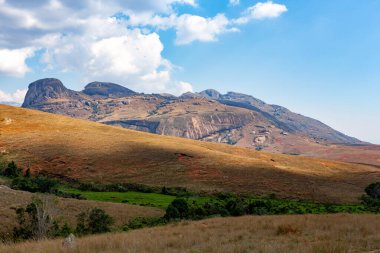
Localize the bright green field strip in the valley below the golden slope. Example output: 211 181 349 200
59 187 209 209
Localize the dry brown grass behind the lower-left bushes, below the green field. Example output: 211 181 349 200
0 189 164 234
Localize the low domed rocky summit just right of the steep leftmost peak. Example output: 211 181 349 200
83 82 136 98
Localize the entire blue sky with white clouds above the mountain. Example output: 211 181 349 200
0 0 380 144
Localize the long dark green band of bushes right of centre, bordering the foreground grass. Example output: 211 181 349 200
165 193 373 220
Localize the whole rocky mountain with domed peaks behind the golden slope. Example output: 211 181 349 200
23 78 364 154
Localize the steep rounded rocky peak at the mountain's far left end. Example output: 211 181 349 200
22 78 70 107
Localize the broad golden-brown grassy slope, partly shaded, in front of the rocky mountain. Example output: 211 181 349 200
0 105 380 202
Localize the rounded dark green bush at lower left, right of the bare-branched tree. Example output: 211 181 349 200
75 208 113 235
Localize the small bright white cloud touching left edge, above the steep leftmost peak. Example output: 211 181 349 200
0 48 35 77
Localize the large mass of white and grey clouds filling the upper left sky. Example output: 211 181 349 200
0 0 287 95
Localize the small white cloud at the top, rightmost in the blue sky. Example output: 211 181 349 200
233 1 288 24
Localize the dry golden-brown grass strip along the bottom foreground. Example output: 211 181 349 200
0 214 380 253
